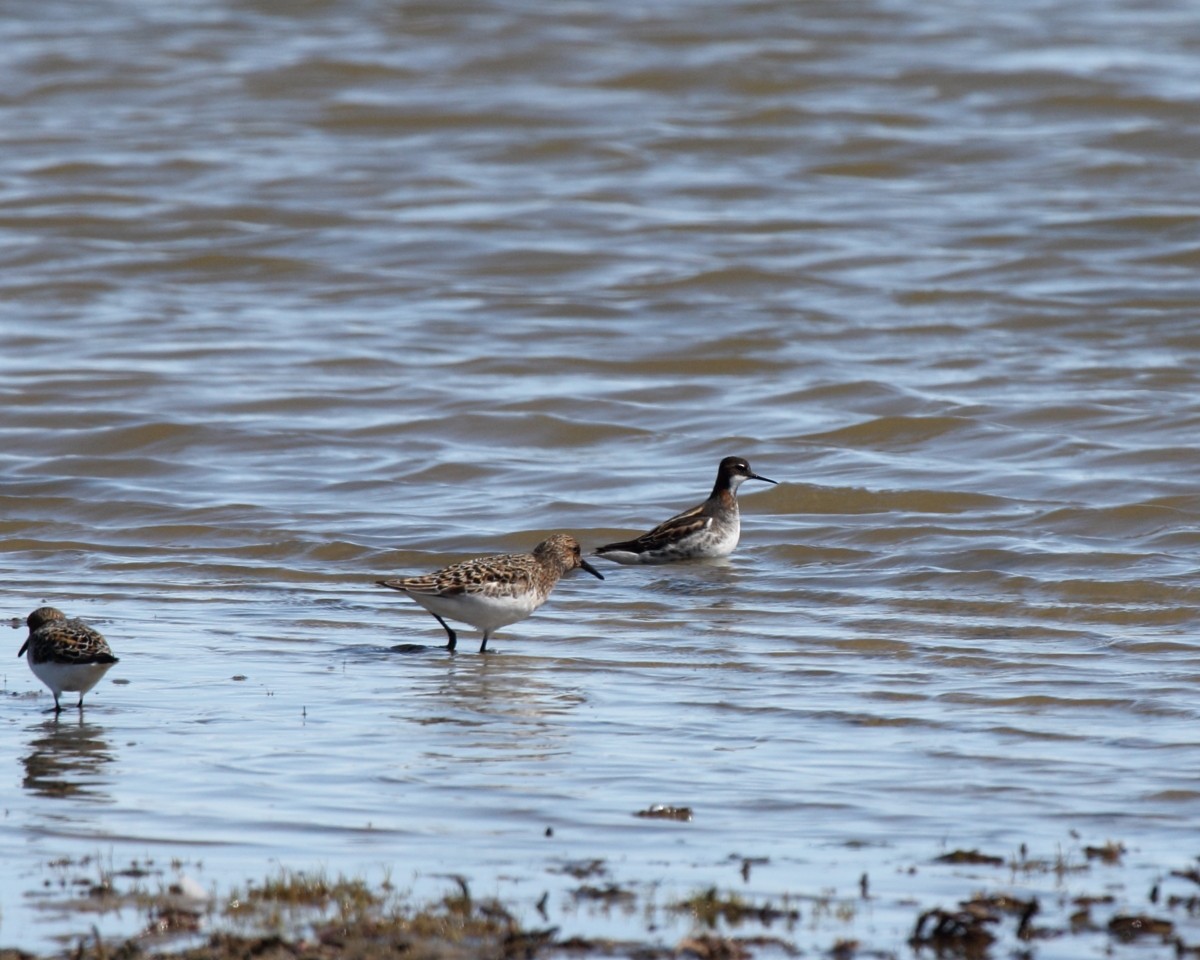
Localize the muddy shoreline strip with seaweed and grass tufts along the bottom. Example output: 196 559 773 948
14 841 1200 960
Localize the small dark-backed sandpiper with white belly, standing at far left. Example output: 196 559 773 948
17 607 118 713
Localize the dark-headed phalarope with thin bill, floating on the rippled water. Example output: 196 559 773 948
596 457 775 563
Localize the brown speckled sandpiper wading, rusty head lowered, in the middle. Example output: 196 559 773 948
378 533 604 653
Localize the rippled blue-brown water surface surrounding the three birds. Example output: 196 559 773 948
0 0 1200 956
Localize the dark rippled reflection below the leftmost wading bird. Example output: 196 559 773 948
22 715 115 800
